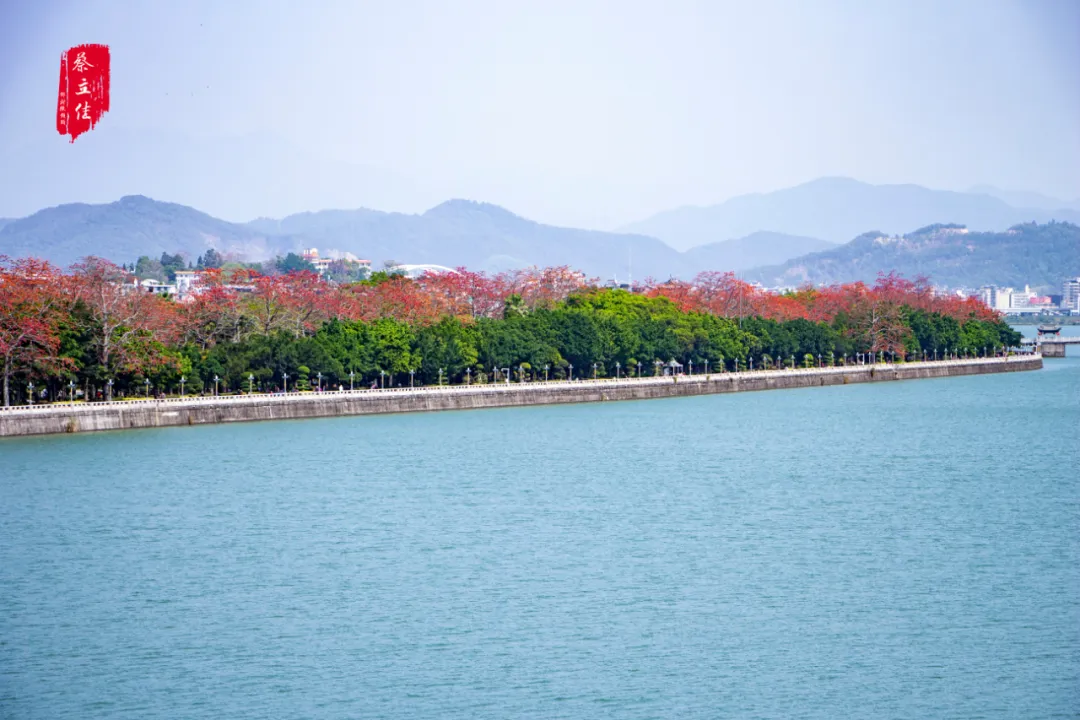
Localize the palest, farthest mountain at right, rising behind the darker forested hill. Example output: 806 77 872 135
621 178 1080 250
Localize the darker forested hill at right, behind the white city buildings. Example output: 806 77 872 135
745 222 1080 290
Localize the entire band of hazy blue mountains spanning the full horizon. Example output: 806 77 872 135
0 178 1080 285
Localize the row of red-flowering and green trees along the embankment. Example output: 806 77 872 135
0 257 1020 405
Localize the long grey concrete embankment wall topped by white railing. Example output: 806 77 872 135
0 355 1042 437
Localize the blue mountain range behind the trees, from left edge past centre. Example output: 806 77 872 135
0 195 831 282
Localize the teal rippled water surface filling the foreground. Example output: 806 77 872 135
0 328 1080 719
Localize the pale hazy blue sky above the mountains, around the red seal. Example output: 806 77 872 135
0 0 1080 229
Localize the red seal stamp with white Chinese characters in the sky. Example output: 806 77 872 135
56 44 109 142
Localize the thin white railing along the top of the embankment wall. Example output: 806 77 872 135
0 354 1039 415
